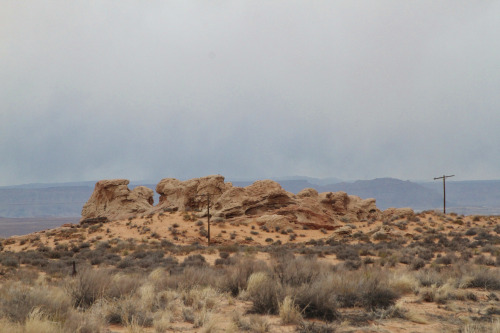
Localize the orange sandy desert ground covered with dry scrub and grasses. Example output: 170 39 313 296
0 211 500 332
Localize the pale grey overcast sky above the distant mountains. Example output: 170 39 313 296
0 0 500 186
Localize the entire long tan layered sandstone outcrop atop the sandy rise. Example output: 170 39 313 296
82 175 410 229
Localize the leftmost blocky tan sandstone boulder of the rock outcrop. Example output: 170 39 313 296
80 179 153 222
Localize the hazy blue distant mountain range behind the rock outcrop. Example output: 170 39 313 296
0 177 500 218
